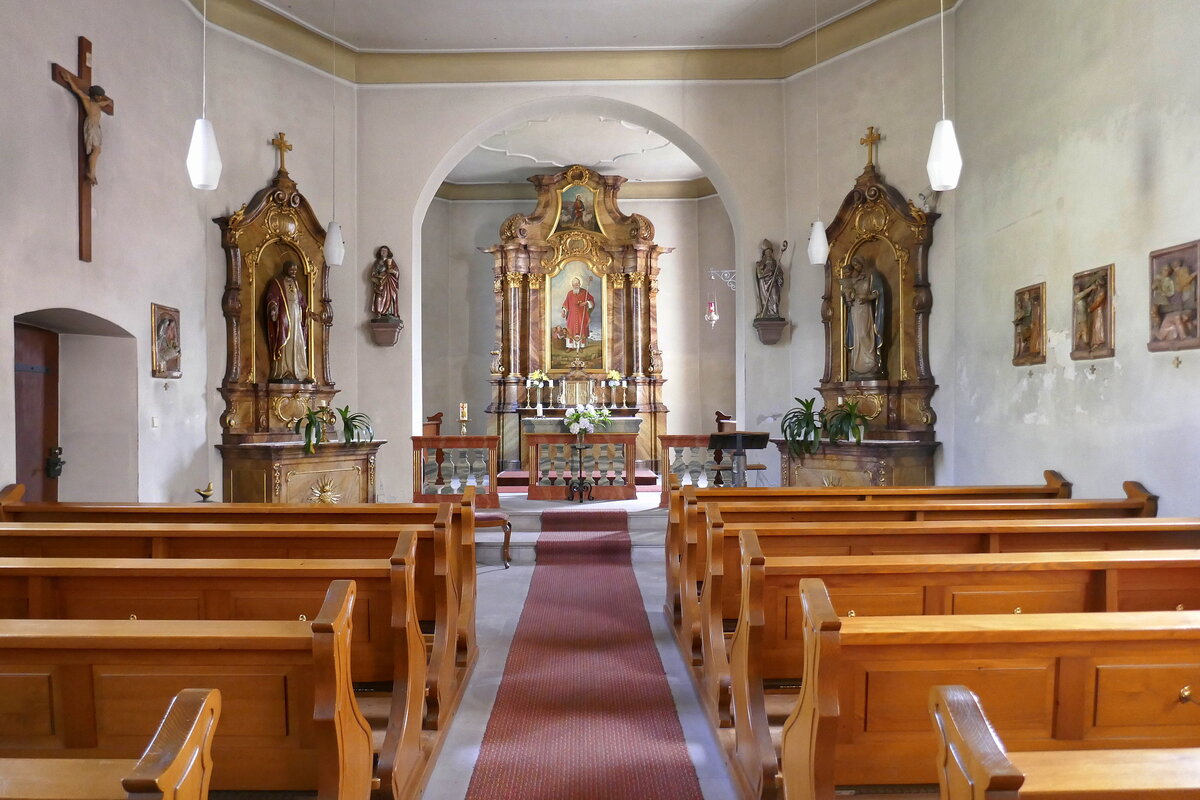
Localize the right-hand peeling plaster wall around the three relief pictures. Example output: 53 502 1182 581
942 0 1200 516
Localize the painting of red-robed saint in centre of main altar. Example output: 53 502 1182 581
546 261 604 369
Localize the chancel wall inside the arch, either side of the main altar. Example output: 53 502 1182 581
421 197 736 441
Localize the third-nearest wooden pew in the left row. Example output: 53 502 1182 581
0 531 432 798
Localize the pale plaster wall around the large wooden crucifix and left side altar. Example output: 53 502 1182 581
0 0 355 500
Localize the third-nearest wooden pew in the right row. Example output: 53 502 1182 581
727 537 1200 796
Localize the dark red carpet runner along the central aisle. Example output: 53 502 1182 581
467 511 702 800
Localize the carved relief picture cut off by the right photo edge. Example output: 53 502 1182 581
1146 241 1200 350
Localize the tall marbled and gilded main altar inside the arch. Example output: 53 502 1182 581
486 166 672 473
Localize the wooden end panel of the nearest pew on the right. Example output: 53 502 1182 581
929 686 1025 800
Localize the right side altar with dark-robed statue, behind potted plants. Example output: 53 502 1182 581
776 127 938 486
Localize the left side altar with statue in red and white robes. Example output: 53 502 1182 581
214 133 384 504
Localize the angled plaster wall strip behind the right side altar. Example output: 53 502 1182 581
782 13 960 483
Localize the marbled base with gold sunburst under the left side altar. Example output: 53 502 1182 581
217 440 385 505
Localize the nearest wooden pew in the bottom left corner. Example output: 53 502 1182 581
0 688 221 800
